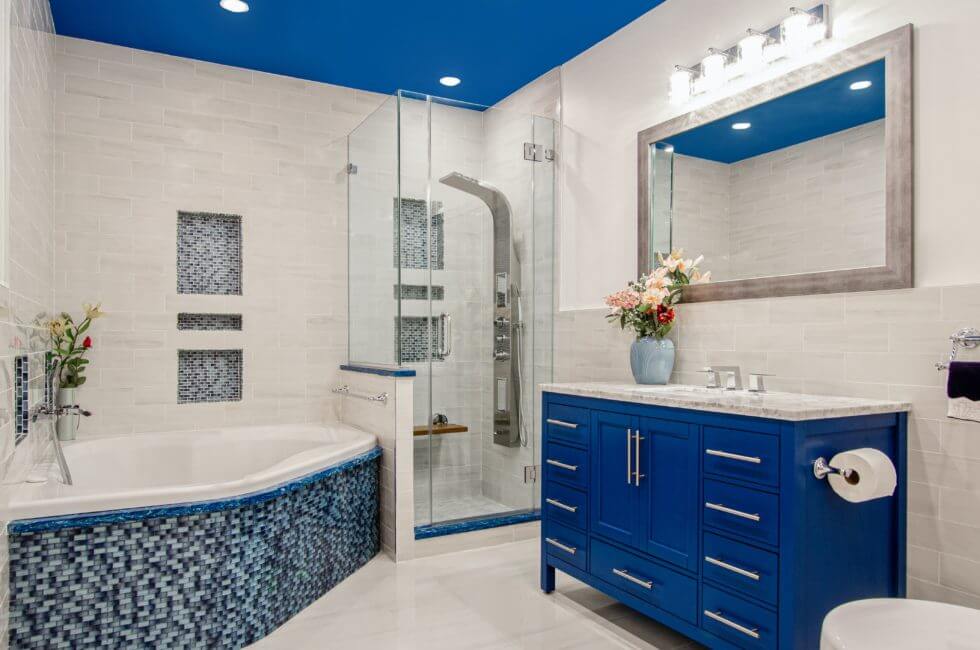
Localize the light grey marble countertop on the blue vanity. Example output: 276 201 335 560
541 382 912 421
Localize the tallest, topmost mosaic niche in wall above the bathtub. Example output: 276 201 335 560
177 212 242 296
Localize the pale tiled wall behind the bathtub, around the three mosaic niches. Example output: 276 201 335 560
55 37 383 436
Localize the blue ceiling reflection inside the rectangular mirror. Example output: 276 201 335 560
658 60 885 163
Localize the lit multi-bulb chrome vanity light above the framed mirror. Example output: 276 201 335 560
670 4 830 104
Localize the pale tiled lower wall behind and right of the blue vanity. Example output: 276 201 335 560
555 285 980 607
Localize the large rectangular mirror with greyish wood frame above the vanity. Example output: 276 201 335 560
638 26 912 301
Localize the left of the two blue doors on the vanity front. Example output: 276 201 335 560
589 411 641 545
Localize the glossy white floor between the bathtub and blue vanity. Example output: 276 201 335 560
252 540 699 650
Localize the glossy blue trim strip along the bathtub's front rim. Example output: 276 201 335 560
7 447 381 534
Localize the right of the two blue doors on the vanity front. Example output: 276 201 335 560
639 418 701 571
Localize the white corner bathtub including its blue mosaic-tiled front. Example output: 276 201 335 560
0 425 381 648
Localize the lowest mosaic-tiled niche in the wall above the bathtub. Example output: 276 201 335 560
177 350 242 404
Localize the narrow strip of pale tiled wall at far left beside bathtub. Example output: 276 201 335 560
0 0 55 647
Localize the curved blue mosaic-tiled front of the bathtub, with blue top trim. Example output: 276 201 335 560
7 449 380 649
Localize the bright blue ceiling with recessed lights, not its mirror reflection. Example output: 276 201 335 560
51 0 664 105
